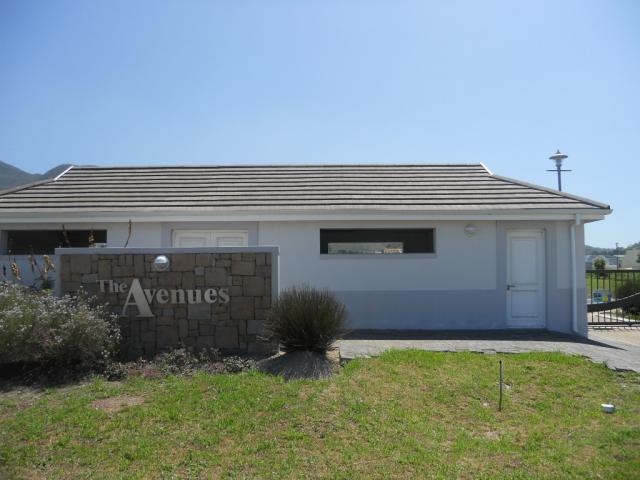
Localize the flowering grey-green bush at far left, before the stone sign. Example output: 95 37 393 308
0 282 120 369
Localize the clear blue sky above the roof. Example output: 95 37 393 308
0 0 640 246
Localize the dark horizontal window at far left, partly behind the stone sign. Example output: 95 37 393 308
7 230 107 255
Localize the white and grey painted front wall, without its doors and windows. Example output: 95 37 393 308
0 221 586 333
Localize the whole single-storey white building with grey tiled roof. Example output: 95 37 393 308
0 164 611 335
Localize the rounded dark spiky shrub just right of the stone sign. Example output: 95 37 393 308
265 285 346 352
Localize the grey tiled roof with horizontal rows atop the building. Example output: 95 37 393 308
0 164 609 214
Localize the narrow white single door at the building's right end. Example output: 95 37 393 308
507 230 546 328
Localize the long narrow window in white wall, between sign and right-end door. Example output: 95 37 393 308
320 228 434 255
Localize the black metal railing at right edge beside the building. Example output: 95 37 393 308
587 270 640 327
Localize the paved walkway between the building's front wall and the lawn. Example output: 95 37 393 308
338 330 640 372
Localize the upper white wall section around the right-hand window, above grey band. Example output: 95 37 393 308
259 222 496 291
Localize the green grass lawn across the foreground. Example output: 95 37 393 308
0 351 640 479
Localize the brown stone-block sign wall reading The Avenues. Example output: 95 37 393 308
56 247 278 358
